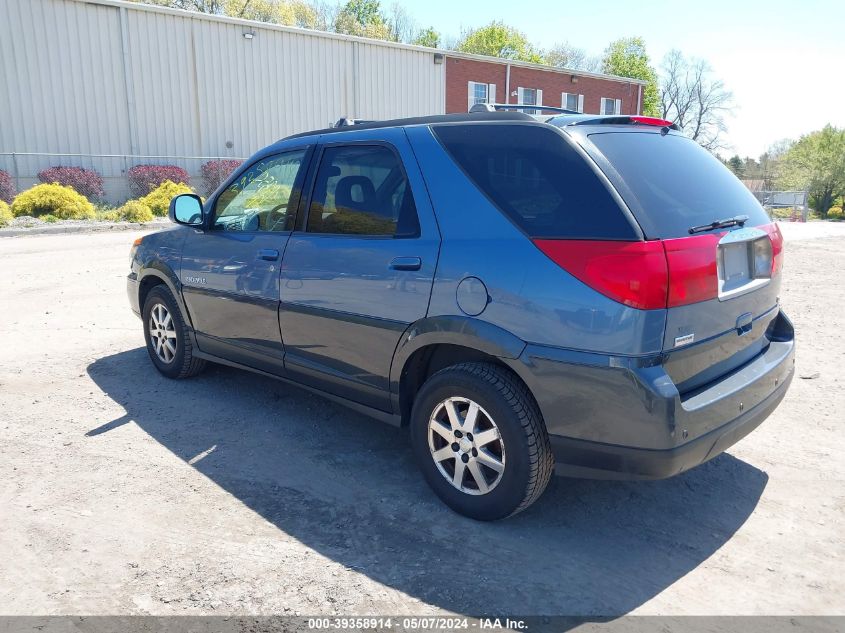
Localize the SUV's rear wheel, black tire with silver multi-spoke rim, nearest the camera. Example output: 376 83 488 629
411 363 554 521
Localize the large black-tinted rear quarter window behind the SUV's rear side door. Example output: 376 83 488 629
434 125 637 239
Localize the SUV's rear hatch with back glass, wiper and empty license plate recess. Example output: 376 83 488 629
578 125 783 395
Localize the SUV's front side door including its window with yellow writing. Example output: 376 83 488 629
181 148 310 374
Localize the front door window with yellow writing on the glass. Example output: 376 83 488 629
212 149 305 231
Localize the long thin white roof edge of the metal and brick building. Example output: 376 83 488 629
73 0 647 85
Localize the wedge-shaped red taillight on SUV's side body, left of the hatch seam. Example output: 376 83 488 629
534 239 669 310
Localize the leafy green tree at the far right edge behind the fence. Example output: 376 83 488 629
778 125 845 218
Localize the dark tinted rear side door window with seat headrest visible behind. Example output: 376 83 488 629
306 145 419 237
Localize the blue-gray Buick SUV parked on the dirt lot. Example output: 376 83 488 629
128 112 794 520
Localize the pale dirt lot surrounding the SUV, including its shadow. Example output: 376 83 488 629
0 227 845 615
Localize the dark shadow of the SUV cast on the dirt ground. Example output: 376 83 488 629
87 348 768 616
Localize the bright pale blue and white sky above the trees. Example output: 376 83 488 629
400 0 845 158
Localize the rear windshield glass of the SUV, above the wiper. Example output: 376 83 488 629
589 132 769 238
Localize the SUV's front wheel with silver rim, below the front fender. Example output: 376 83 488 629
141 284 206 378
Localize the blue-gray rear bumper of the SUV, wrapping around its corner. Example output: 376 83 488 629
514 313 795 479
